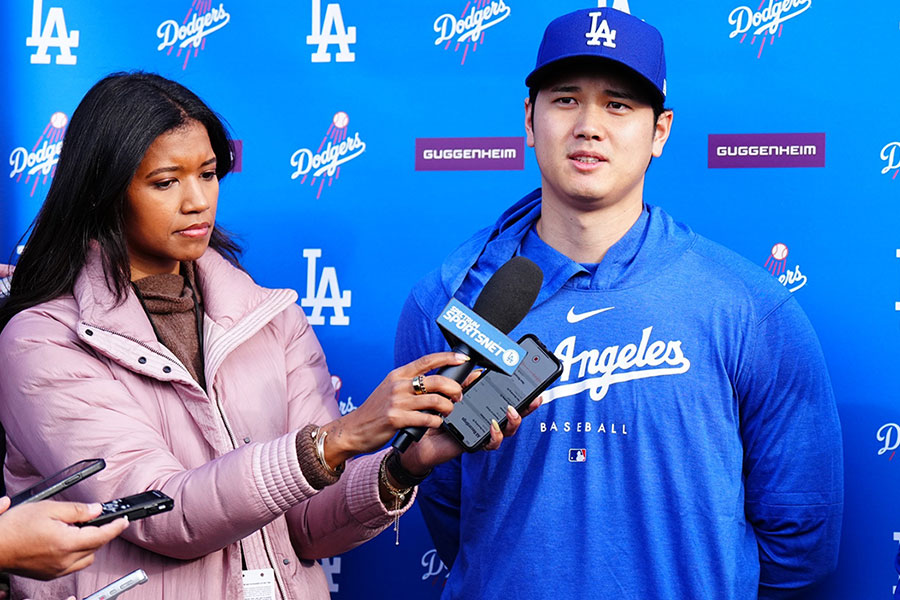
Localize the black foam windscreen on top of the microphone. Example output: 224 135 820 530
472 256 544 333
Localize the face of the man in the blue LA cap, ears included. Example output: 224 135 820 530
525 73 672 216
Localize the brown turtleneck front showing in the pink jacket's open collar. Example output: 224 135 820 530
134 263 206 389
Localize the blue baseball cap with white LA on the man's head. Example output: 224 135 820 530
525 8 666 99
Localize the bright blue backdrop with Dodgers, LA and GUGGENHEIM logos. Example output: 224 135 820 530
0 0 900 600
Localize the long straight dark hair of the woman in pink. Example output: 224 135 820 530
0 72 240 329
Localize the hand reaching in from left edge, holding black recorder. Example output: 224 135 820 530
0 496 128 580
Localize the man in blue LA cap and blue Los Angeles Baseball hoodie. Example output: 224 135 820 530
396 8 843 600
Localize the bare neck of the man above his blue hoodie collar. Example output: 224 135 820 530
537 199 643 263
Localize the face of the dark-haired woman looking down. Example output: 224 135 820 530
125 121 219 281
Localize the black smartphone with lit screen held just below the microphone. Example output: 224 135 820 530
444 333 562 452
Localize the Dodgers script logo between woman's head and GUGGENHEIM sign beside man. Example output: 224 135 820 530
291 112 366 199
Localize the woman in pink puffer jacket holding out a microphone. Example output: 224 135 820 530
0 73 532 599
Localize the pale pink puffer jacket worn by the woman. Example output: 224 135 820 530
0 248 409 600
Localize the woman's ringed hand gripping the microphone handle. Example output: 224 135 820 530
322 352 472 467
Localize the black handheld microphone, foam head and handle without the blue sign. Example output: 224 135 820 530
391 256 544 452
